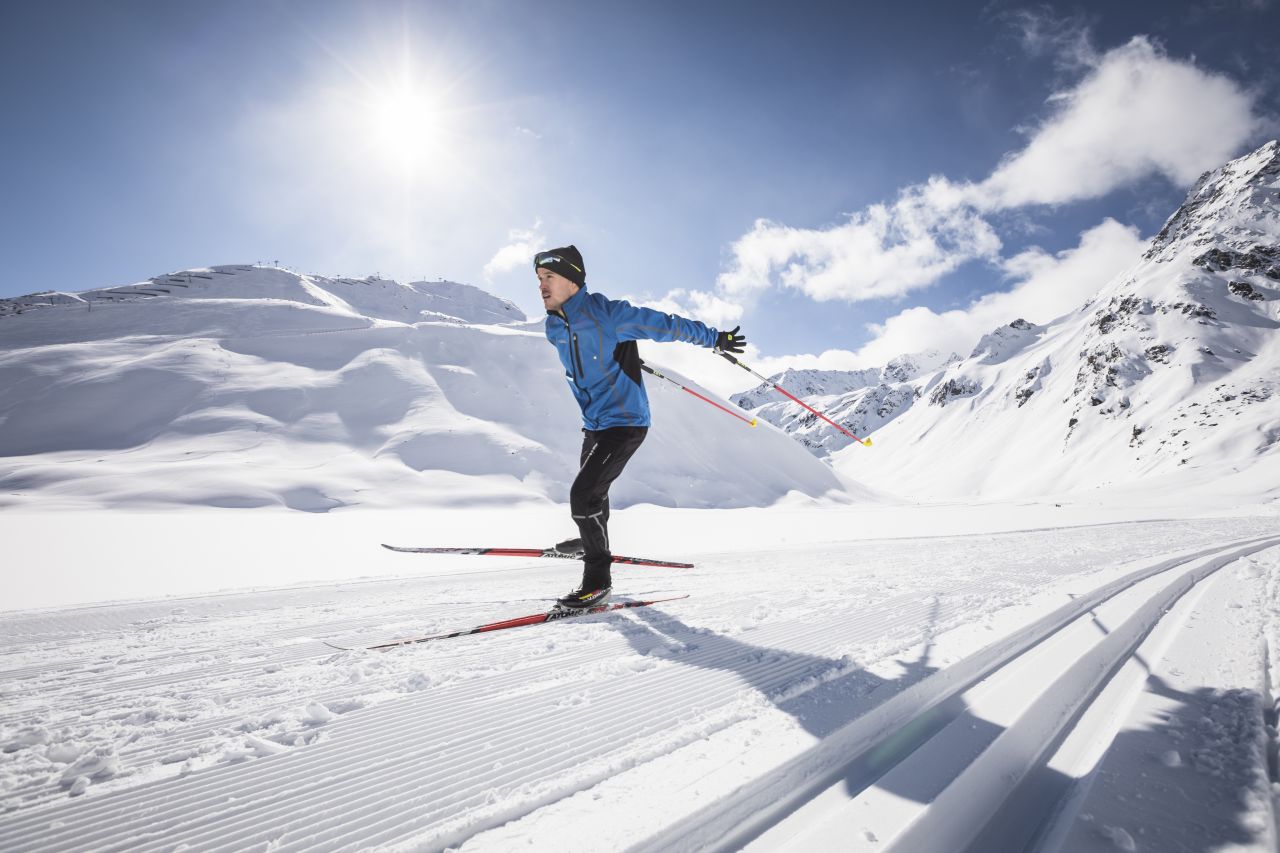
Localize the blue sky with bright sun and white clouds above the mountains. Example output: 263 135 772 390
0 0 1280 381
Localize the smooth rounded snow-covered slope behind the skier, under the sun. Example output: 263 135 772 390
0 266 860 510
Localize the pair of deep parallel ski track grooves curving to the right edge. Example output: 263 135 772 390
628 537 1280 853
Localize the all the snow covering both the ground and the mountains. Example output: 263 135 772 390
0 143 1280 853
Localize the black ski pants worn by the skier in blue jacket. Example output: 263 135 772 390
568 427 649 589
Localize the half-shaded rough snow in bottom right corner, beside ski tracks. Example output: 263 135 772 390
1053 552 1280 850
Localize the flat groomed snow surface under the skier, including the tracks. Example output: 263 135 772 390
0 505 1280 853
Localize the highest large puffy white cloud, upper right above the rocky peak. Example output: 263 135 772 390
970 36 1260 210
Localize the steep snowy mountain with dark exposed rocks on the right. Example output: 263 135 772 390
832 142 1280 497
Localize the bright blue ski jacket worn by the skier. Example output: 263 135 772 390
547 286 718 430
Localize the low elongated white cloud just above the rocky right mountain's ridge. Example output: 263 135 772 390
851 219 1147 366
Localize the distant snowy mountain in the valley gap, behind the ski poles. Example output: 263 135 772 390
730 350 960 457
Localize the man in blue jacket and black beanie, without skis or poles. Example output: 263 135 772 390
534 246 746 608
